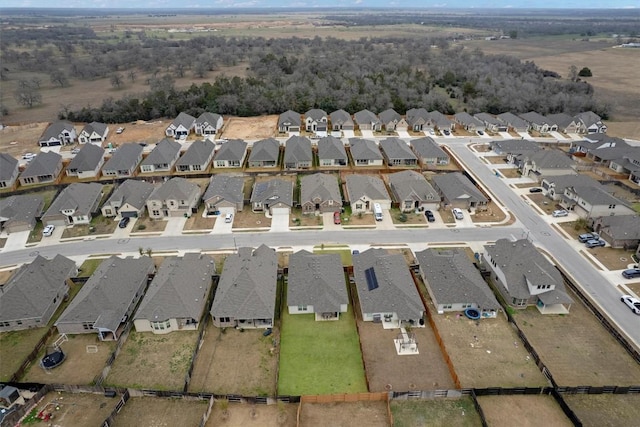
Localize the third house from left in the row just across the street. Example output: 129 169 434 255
101 179 155 218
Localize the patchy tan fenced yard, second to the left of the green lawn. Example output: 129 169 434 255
105 329 198 390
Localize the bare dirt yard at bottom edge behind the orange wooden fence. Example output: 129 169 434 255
300 402 390 427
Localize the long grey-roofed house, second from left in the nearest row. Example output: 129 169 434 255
55 255 155 341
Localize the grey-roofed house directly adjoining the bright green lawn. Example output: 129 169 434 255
287 250 349 321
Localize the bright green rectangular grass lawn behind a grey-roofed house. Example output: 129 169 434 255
278 307 367 396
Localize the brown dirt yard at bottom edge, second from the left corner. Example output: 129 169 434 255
113 397 209 427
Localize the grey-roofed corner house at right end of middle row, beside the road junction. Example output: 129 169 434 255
433 172 489 209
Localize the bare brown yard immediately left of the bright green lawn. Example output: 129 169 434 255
189 323 279 396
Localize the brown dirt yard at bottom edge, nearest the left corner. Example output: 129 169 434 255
25 392 118 427
